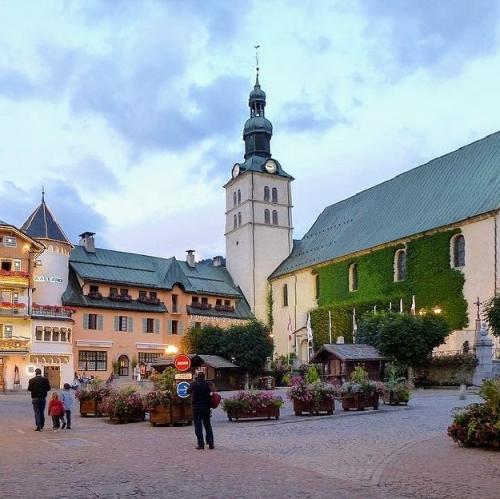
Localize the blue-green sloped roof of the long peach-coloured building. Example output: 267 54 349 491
69 246 248 298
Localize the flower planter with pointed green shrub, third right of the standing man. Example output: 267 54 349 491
338 366 384 411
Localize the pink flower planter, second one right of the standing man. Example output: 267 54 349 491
287 377 335 416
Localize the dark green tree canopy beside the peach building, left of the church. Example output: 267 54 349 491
183 321 273 375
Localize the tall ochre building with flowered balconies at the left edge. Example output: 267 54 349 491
0 220 44 391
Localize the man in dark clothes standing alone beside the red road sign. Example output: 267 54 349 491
188 372 214 449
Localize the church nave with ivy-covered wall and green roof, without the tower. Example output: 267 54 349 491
268 132 500 360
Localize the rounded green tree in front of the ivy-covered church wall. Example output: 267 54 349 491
357 313 450 367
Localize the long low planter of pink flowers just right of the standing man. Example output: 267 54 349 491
222 390 283 421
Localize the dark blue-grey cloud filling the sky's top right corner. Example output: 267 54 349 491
359 0 499 74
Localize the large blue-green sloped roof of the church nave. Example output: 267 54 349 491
271 132 500 278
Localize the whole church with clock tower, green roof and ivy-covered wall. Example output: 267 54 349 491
224 73 500 361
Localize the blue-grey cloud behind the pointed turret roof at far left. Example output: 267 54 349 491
0 180 108 246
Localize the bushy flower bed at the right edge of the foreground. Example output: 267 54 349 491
448 379 500 451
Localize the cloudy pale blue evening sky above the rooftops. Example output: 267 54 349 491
0 0 500 258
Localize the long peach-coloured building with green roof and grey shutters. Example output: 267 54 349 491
63 232 252 378
